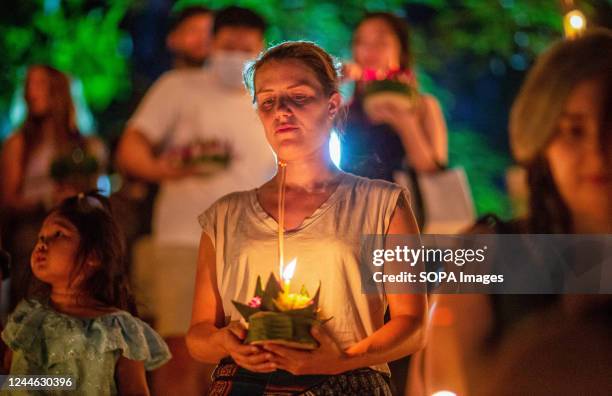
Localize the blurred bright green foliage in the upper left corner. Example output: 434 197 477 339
0 0 130 115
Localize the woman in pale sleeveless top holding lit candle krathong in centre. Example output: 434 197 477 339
187 42 427 395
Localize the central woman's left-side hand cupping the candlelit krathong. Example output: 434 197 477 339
221 321 276 373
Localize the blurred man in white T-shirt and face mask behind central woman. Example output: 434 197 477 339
117 7 275 395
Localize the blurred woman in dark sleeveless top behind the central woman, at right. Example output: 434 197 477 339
341 12 448 181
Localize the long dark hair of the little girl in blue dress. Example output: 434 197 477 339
28 192 136 314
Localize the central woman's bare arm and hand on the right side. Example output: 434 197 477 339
265 195 427 375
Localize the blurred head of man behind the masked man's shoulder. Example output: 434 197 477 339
166 6 214 69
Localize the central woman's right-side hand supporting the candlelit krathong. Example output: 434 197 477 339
264 326 349 375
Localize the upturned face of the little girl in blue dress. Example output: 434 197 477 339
30 213 80 288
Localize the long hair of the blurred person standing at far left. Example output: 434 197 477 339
20 65 83 169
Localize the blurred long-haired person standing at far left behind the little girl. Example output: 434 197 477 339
0 65 107 312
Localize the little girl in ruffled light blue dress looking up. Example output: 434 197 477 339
2 193 170 395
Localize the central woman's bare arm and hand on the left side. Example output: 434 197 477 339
186 233 274 372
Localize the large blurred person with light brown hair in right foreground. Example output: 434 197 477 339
410 29 612 394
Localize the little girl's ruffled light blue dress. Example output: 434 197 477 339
2 300 170 395
